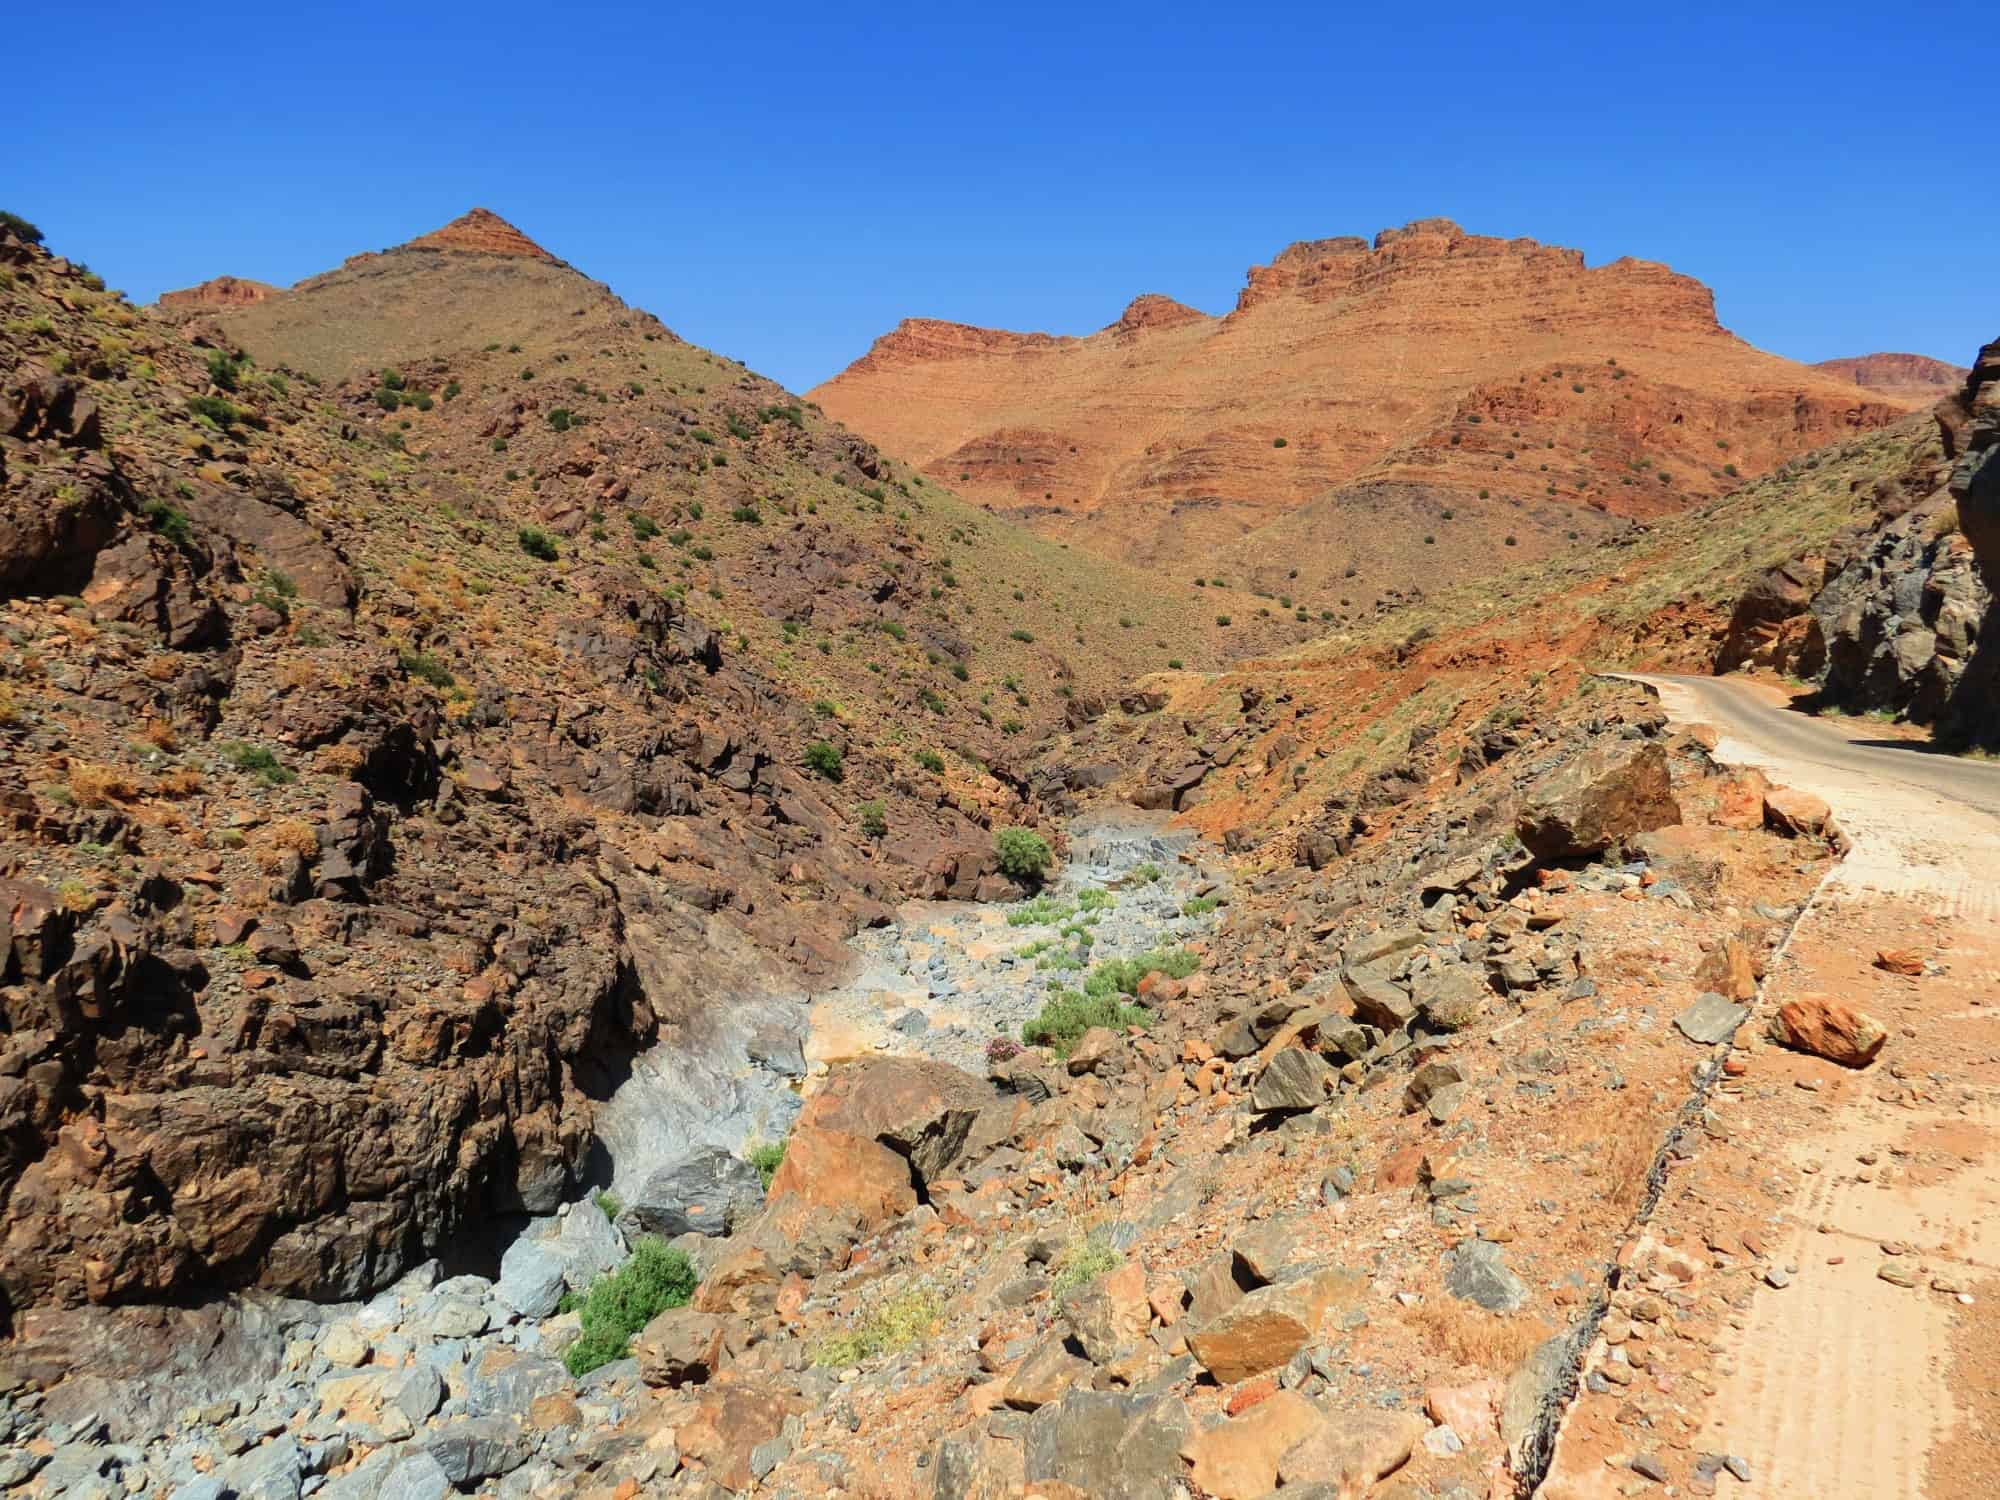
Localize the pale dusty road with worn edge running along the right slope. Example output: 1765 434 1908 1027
1552 678 2000 1500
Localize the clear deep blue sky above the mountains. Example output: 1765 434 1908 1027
0 0 2000 388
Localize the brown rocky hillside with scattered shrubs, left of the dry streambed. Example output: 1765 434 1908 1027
0 206 1292 1320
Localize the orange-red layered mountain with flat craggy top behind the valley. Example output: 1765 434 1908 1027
812 218 1910 608
